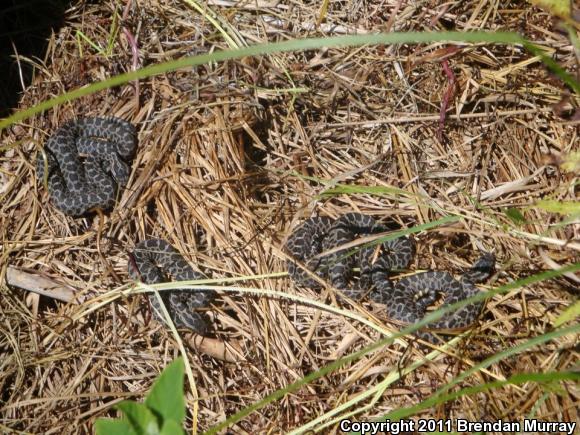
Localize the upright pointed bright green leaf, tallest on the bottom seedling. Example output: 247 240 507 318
145 358 185 425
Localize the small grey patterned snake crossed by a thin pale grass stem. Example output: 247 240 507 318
128 239 214 335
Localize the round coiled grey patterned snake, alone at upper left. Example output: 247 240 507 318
36 117 137 216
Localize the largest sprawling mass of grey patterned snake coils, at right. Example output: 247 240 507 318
286 213 495 342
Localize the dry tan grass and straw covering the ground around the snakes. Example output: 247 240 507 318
0 0 579 434
